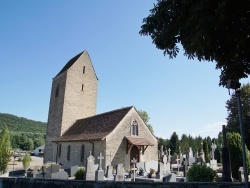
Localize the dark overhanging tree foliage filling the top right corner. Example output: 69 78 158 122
140 0 250 86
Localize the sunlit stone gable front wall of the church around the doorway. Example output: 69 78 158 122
106 108 158 170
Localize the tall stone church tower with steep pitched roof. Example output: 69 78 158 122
44 51 98 163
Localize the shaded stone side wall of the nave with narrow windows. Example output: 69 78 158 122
57 140 105 168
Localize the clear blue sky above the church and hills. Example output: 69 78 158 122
0 0 248 138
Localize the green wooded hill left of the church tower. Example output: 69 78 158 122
0 113 47 135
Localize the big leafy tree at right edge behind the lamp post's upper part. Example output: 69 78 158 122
226 83 250 148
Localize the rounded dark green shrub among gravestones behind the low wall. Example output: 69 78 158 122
187 163 217 182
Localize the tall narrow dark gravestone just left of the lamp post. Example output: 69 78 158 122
221 125 233 182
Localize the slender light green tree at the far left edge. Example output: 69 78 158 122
0 126 11 173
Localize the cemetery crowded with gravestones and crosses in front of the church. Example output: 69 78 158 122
0 141 248 188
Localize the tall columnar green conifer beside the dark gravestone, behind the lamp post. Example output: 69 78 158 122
227 133 250 179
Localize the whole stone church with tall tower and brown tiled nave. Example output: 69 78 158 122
44 51 158 170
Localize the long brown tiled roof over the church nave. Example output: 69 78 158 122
55 106 133 142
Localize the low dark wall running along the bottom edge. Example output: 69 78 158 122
0 178 245 188
